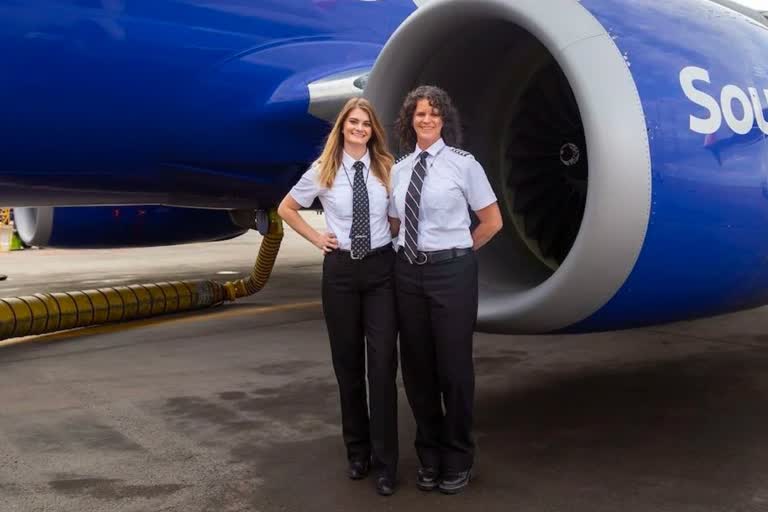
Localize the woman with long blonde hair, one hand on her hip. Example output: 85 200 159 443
278 98 398 496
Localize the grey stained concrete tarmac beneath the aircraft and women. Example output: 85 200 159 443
0 217 768 512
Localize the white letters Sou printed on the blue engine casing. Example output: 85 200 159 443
680 66 768 135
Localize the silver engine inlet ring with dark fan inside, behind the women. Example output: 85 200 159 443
365 0 651 332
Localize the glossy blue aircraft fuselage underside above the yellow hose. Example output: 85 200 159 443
0 0 416 208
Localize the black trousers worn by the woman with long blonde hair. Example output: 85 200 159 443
322 247 398 477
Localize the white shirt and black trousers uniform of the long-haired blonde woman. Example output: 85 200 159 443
290 152 398 479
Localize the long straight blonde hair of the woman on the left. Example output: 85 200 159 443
315 98 395 193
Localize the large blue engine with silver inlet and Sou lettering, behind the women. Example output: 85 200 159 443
365 0 768 332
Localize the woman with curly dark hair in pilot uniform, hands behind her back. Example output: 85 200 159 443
389 86 502 494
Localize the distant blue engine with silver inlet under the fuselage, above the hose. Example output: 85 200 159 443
13 206 247 249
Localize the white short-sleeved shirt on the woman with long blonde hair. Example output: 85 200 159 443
290 151 392 251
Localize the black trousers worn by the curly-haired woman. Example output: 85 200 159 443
395 252 478 471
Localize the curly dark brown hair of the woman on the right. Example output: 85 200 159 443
395 85 463 151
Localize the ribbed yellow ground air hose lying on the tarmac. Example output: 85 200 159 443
0 210 283 340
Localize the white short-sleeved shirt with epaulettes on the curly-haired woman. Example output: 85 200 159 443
389 139 496 251
